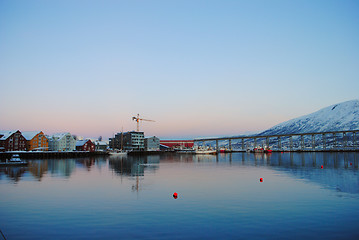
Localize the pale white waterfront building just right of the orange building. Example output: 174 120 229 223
48 132 76 151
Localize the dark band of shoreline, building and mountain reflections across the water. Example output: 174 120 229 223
0 153 359 194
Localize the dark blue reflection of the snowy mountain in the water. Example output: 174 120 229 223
225 153 359 194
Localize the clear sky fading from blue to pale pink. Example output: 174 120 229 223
0 0 359 139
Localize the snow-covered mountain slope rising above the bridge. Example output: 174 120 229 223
258 100 359 135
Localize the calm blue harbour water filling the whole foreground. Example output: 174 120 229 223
0 153 359 240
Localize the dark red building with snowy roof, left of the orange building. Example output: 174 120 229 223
0 130 26 152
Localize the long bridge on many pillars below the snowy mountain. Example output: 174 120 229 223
193 130 359 152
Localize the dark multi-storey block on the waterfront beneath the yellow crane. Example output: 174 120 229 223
110 131 145 151
